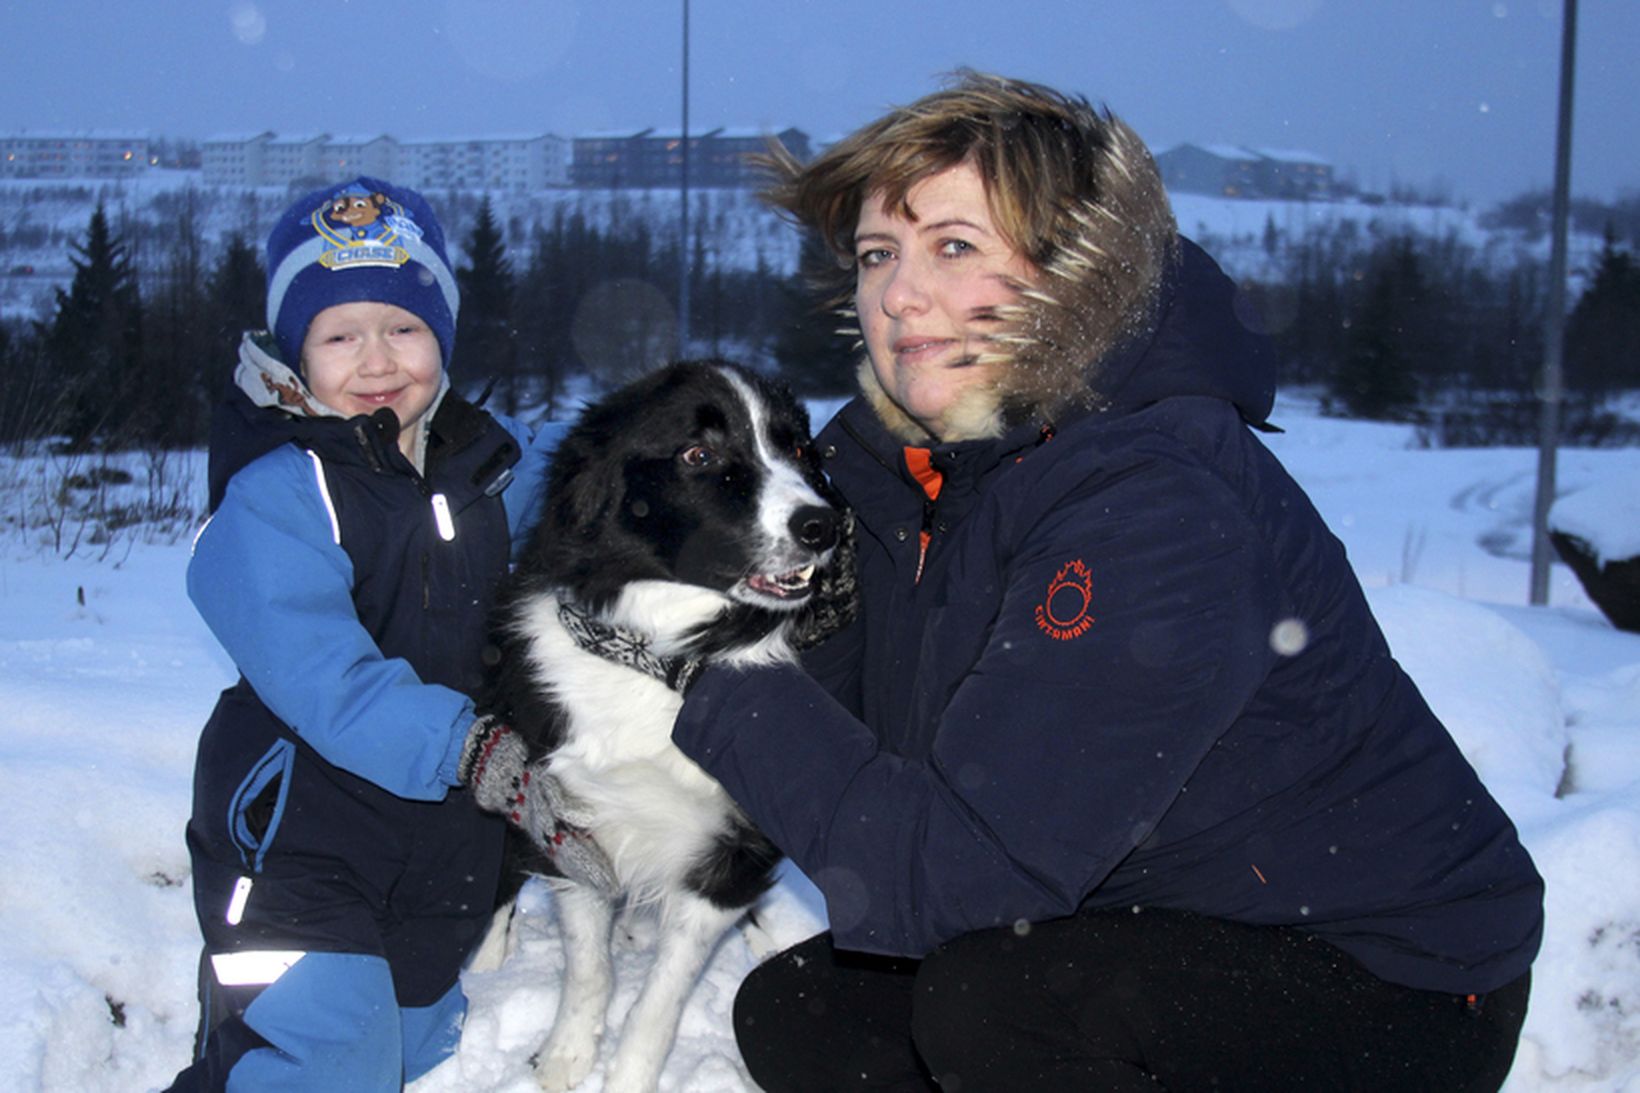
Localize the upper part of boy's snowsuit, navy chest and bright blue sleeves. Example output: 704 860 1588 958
189 341 558 801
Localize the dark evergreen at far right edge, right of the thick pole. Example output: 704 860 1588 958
1566 230 1640 405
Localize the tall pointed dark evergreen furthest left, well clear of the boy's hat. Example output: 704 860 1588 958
43 202 146 450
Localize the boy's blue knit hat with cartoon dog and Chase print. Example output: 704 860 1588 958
267 177 461 368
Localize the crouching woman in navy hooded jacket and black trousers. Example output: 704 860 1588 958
674 74 1542 1093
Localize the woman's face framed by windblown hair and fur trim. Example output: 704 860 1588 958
854 162 1035 440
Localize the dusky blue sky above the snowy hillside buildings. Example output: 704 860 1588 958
0 0 1640 202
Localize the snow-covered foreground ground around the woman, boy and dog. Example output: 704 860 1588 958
0 393 1640 1093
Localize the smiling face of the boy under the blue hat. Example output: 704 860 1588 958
302 302 444 455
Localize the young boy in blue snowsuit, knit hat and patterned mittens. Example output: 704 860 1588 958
172 177 558 1091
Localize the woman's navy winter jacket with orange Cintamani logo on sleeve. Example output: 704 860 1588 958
674 241 1542 993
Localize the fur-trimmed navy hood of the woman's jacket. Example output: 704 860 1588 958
858 123 1274 445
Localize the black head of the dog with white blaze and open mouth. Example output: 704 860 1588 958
520 361 840 646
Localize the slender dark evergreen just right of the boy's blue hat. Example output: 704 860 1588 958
453 195 522 414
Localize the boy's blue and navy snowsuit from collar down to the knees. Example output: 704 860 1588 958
189 338 567 1008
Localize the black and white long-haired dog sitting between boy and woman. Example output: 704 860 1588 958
475 361 841 1093
